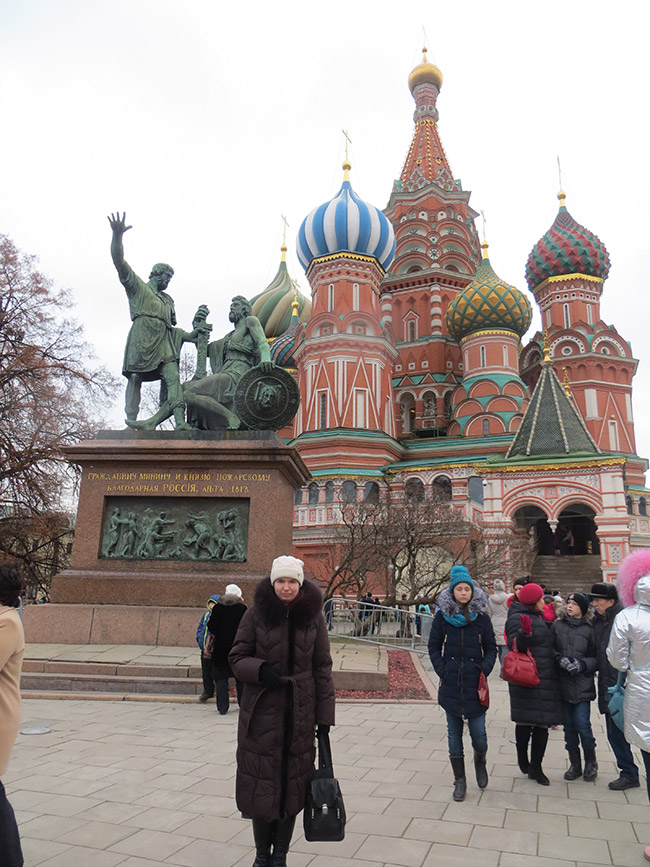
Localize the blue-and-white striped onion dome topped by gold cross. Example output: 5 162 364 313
297 159 395 271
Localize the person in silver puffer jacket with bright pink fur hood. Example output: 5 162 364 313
607 548 650 861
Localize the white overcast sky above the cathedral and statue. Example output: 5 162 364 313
0 0 650 468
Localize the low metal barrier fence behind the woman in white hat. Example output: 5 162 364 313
323 599 433 655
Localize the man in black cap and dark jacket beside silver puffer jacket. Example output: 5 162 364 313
589 581 639 791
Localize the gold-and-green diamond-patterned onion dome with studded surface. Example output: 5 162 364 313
446 242 533 343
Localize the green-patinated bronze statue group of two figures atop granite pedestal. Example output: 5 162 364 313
105 213 300 434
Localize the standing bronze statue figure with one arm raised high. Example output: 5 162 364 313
108 213 198 430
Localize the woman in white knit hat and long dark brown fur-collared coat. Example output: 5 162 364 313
229 557 334 867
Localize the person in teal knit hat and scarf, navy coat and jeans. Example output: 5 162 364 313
429 566 497 801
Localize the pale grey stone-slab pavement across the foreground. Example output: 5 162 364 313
6 675 650 867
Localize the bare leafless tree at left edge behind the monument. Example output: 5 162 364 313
0 235 117 588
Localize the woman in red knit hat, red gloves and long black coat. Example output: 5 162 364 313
506 583 563 786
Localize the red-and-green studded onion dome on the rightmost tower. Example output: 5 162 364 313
526 191 610 289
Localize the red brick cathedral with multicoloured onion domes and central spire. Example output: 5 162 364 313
247 49 650 586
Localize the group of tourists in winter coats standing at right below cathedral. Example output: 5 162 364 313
428 549 650 860
